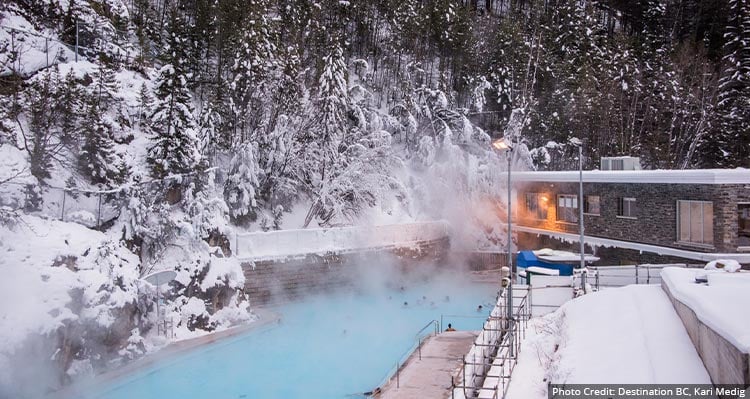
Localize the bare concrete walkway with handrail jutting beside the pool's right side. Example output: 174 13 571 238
376 331 478 399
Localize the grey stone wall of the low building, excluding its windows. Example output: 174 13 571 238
518 182 750 252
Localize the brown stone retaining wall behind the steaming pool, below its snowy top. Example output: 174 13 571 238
242 238 450 305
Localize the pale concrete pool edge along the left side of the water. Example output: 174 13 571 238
50 308 281 399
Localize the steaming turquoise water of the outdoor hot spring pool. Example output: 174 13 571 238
86 282 496 399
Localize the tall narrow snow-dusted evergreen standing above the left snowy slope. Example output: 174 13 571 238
148 10 200 177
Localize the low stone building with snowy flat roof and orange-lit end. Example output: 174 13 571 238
512 169 750 265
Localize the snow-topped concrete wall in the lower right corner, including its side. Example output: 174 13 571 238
661 267 750 386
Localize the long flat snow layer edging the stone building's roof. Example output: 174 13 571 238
511 168 750 184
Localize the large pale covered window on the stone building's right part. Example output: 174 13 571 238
677 201 714 245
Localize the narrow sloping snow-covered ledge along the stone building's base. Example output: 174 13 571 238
513 225 750 264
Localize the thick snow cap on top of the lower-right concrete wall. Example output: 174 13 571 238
661 267 750 352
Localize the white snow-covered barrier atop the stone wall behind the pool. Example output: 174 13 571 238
232 221 449 259
